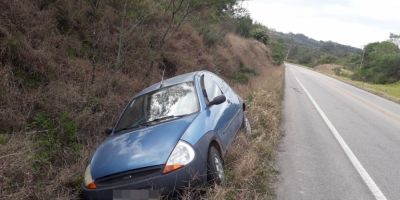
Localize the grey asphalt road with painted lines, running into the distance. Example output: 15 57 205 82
277 64 400 200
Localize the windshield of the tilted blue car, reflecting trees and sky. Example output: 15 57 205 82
115 82 199 132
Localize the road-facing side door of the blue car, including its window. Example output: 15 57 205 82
201 74 230 149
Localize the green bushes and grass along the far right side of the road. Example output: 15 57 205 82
288 34 400 102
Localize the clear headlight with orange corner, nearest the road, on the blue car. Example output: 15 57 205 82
163 140 195 174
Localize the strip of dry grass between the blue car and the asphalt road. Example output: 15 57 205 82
205 66 283 200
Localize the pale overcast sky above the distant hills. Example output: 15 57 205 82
243 0 400 48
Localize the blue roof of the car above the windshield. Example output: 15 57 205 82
135 70 211 97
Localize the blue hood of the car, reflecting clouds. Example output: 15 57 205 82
90 115 196 180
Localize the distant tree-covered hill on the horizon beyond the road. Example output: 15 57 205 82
269 30 362 66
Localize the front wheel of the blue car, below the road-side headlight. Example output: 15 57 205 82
207 146 225 184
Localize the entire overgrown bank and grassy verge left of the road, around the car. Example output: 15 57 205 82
0 0 284 199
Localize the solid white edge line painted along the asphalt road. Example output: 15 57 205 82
293 70 387 200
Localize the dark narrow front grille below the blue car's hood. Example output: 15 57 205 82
96 166 162 187
